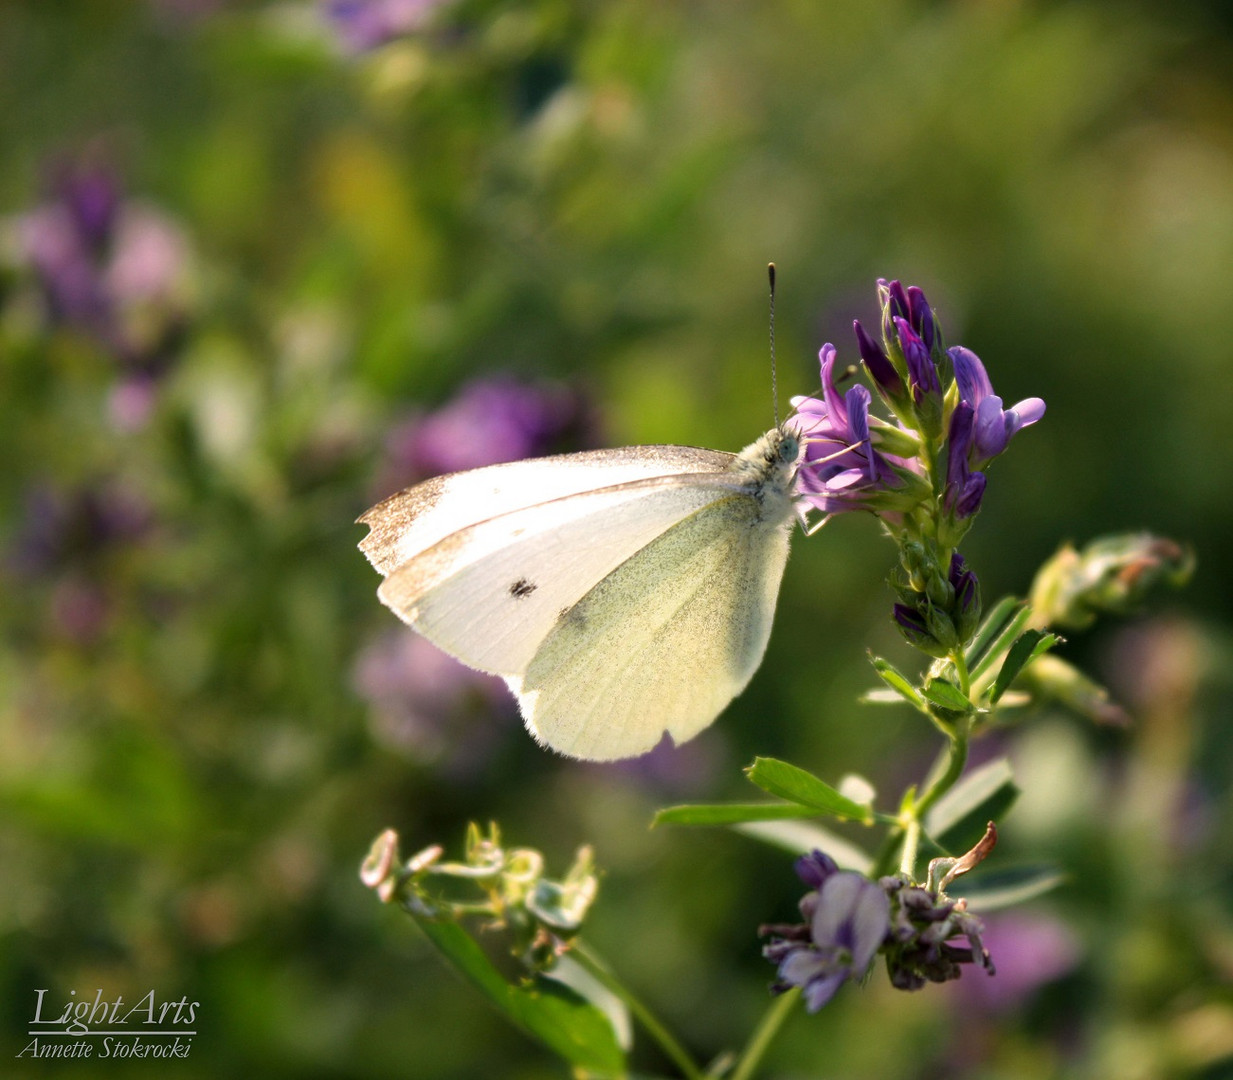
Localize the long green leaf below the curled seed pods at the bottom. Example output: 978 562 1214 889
411 911 625 1075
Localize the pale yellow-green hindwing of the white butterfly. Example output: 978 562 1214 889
509 493 788 761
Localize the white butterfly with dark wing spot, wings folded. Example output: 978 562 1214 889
360 428 801 761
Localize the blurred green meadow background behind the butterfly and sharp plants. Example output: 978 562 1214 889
0 0 1233 1080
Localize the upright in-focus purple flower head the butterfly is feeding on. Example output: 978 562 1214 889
792 273 1044 657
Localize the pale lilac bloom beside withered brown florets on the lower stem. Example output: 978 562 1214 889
762 867 890 1012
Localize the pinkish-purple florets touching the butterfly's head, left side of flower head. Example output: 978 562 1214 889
792 343 921 514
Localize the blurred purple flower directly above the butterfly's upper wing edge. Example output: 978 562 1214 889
379 375 596 491
